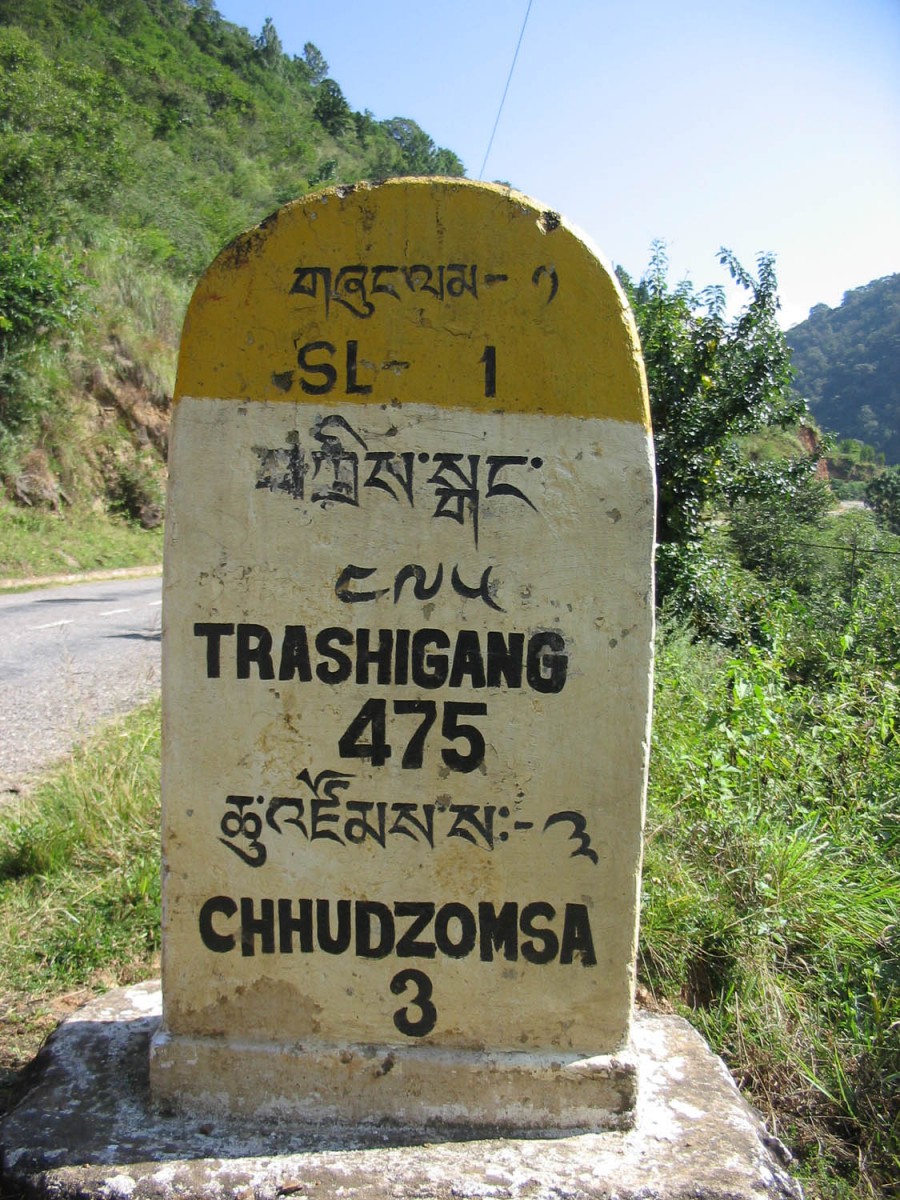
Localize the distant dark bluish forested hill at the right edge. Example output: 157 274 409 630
786 275 900 463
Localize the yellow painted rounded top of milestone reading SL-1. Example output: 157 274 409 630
175 179 649 428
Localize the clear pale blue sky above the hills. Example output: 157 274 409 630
217 0 900 326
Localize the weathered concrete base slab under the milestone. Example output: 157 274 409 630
0 983 802 1200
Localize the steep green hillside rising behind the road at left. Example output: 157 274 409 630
0 0 463 516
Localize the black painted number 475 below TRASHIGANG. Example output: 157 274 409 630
337 700 487 772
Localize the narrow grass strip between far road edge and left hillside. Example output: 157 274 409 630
0 500 162 583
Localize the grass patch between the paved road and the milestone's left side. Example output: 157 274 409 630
0 700 160 1110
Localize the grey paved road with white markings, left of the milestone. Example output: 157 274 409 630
0 577 162 800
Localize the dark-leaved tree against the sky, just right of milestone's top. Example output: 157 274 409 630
619 242 812 614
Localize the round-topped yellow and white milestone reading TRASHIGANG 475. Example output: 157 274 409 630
150 180 654 1129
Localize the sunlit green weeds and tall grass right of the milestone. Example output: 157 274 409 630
641 604 900 1196
